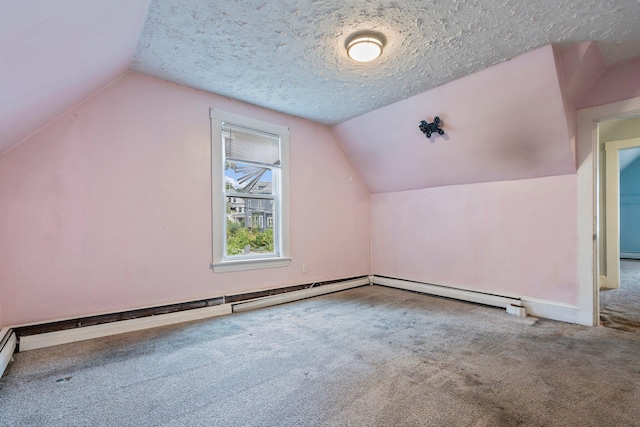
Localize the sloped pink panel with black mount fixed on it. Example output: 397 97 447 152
334 46 576 193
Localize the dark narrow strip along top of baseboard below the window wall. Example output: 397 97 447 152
12 276 368 342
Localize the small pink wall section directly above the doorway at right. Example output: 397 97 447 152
576 57 640 109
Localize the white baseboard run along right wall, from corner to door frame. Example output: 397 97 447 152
373 276 580 324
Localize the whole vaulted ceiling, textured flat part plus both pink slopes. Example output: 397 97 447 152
0 0 640 192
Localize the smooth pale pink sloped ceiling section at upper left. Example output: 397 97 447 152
0 0 149 153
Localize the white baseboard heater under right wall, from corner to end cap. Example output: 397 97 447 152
373 276 522 314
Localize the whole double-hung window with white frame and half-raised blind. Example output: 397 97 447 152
211 109 291 272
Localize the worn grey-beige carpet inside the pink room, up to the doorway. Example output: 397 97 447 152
0 286 640 426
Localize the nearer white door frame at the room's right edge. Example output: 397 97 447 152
576 97 640 326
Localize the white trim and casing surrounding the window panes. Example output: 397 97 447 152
210 108 291 273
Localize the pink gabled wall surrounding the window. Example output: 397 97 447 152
0 73 371 325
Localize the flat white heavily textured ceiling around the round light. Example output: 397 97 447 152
132 0 640 124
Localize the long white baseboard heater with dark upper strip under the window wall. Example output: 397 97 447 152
12 276 371 353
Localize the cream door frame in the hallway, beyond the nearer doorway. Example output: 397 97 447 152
600 138 640 289
